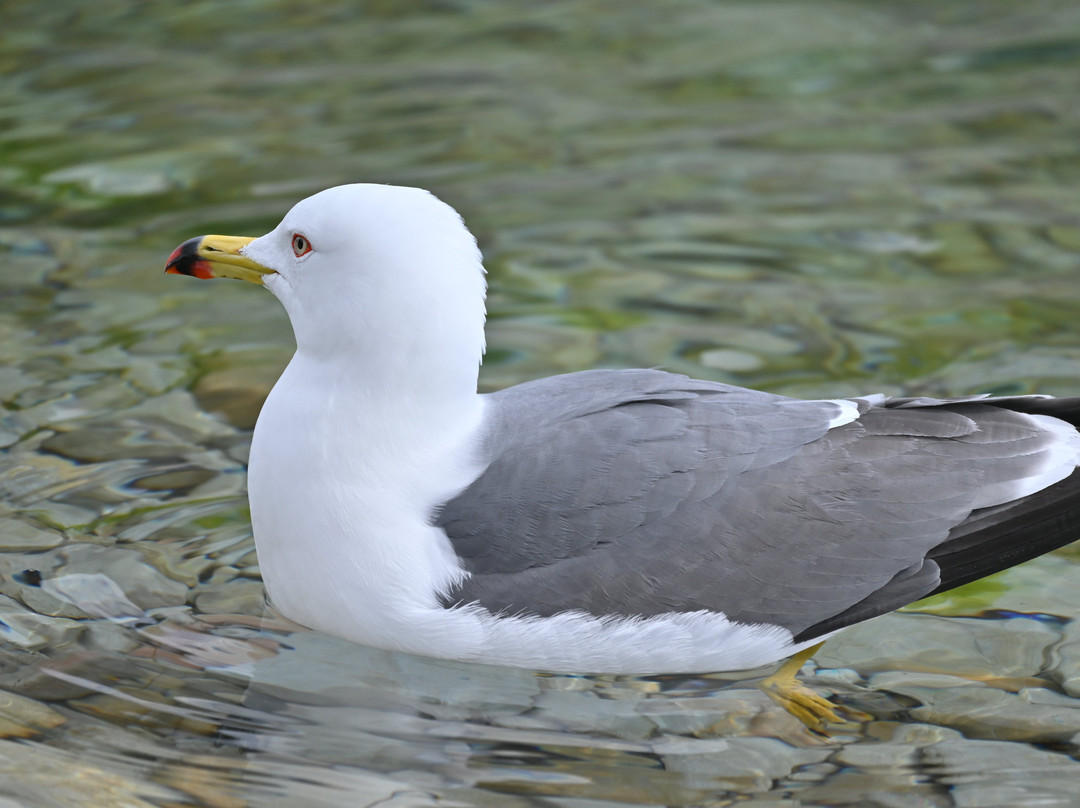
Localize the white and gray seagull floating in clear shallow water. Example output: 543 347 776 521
165 184 1080 717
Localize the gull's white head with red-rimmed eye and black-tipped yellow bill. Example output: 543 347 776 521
167 185 485 406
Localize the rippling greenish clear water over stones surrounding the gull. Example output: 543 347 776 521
0 0 1080 808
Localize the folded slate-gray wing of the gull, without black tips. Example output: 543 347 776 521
434 371 1080 638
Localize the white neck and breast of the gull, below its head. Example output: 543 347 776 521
248 352 484 651
